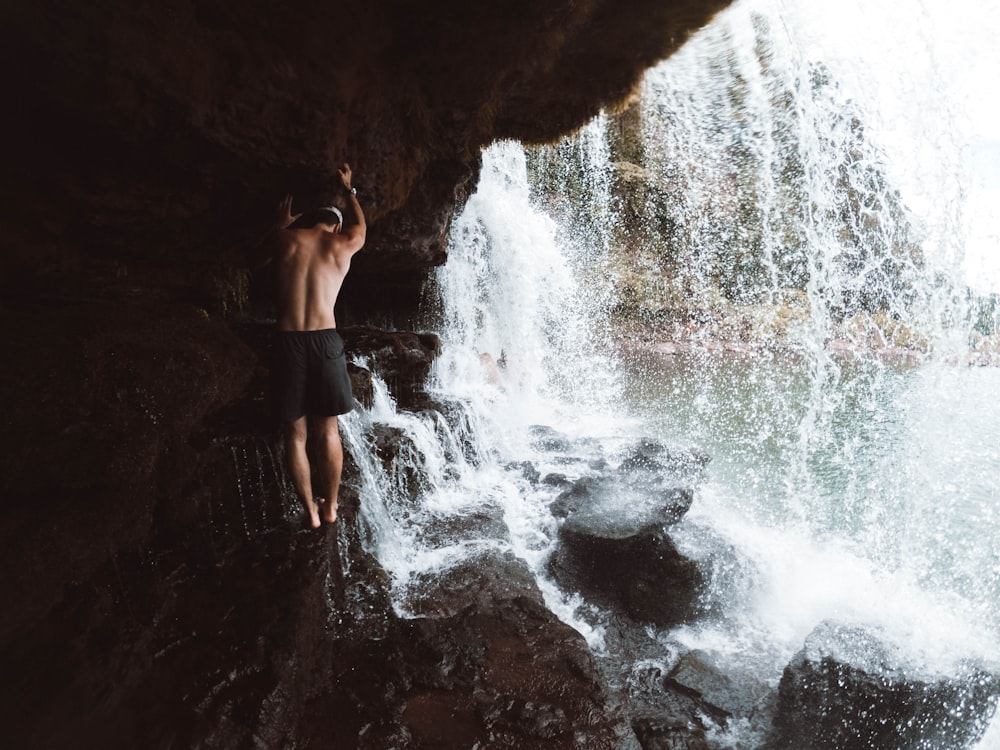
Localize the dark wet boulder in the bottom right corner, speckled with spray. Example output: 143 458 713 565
768 621 1000 750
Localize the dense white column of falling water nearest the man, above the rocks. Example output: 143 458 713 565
435 137 613 424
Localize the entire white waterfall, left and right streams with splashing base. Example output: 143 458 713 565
342 0 1000 748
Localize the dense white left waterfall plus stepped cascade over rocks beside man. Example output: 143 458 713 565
342 140 620 647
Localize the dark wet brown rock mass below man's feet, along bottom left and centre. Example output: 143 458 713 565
0 414 619 750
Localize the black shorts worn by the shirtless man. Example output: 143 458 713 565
271 328 354 422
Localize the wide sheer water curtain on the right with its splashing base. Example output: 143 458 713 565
592 2 1000 748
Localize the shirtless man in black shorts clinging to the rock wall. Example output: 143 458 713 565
266 164 366 529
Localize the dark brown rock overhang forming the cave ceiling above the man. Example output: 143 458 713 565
0 0 725 297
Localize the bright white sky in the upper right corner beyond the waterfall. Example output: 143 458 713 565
776 0 1000 291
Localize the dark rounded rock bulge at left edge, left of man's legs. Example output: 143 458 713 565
0 299 254 639
